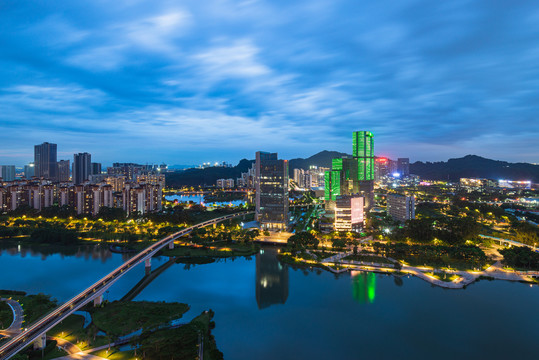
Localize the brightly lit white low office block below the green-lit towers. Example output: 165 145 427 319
334 196 365 232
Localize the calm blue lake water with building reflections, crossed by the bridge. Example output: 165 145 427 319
0 243 539 359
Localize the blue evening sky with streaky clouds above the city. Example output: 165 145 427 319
0 0 539 165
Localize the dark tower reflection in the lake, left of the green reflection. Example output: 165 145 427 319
255 248 288 309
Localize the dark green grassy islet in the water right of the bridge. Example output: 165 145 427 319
92 301 189 337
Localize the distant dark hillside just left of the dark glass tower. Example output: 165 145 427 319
165 159 254 187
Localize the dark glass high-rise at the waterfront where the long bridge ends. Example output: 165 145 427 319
255 151 288 230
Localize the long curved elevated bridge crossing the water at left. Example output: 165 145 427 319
0 211 252 360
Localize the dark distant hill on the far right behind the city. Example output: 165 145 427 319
410 155 539 183
